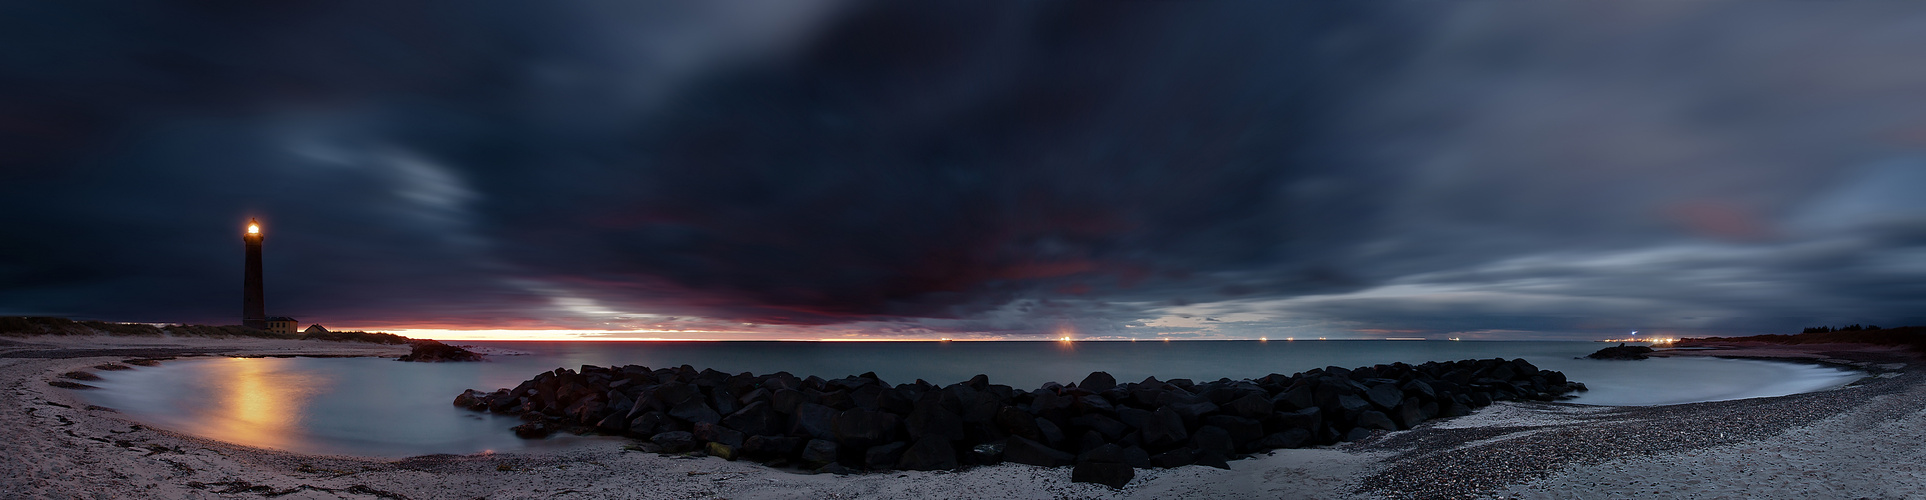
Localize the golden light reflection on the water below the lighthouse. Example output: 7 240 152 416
193 358 327 450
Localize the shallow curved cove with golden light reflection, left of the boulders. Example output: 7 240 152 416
85 358 605 458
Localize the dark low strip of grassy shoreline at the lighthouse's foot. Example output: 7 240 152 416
0 315 408 344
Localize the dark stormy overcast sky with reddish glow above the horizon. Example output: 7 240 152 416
0 0 1926 338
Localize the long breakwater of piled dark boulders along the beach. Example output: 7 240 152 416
455 360 1585 487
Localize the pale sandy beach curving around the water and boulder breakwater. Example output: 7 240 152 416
0 337 1926 498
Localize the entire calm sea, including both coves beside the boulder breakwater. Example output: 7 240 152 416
83 340 1859 458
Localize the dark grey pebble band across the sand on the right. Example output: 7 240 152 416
1358 353 1926 498
